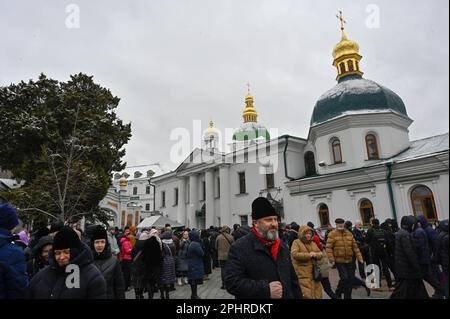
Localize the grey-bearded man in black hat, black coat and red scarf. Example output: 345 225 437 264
225 197 302 299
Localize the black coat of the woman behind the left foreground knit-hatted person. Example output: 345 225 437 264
92 244 125 299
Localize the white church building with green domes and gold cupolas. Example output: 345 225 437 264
103 16 449 228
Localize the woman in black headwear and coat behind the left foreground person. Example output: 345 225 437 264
91 225 125 299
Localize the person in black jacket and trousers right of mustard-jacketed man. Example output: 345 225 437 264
366 218 393 290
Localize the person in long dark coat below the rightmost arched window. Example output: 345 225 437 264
391 216 428 299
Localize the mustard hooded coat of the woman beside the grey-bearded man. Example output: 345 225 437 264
291 226 322 299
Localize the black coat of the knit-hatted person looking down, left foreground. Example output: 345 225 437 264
27 244 106 299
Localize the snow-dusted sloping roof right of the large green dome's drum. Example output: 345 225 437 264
390 133 449 162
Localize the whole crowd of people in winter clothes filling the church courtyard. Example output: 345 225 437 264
0 197 449 299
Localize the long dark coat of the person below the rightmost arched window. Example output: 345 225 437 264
395 229 422 279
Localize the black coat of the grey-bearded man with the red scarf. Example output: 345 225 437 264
225 233 302 299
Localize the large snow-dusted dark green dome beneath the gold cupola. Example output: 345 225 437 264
311 75 408 126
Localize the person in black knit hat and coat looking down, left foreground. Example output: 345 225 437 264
28 226 106 299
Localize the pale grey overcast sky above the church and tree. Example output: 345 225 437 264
0 0 449 174
